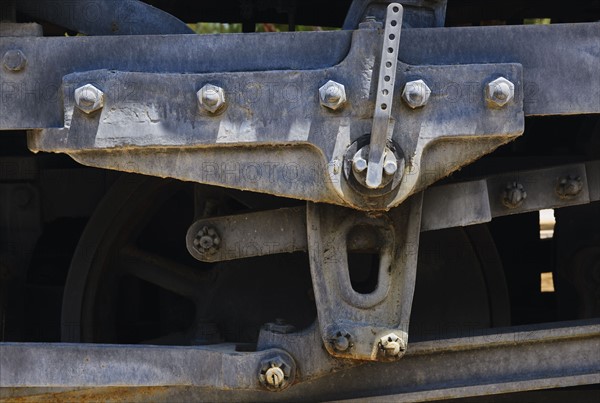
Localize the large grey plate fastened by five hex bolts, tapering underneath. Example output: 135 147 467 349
29 29 524 210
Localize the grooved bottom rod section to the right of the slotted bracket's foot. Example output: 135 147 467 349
332 321 600 402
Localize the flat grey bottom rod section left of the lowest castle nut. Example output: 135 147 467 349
0 343 296 389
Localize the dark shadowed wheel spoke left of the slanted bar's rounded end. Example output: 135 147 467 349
120 246 212 299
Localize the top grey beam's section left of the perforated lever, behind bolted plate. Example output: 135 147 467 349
0 31 352 129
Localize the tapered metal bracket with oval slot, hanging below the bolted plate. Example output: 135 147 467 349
307 194 422 361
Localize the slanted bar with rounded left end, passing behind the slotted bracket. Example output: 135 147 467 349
186 161 600 262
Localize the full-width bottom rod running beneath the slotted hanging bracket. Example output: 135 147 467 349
0 321 600 401
